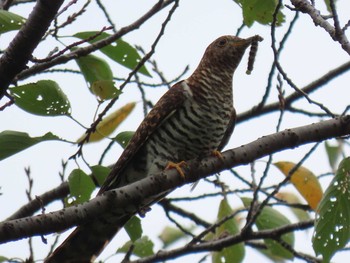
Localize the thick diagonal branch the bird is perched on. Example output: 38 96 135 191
0 115 350 243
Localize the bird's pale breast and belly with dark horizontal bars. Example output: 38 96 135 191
145 78 233 174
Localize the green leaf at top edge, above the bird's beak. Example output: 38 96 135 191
235 0 285 27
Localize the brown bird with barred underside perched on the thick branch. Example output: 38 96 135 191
45 35 262 263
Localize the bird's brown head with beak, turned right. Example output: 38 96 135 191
201 35 262 73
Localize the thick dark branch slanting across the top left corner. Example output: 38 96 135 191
0 0 64 99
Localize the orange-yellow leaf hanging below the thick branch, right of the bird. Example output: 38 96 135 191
274 162 323 210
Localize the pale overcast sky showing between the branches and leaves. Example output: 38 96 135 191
0 0 350 262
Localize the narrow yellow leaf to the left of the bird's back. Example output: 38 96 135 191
77 102 136 143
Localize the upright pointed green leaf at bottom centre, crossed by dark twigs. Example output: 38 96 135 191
212 198 245 263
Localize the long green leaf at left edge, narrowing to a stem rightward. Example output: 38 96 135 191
0 130 61 161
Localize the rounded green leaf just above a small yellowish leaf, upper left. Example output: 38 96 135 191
75 55 113 85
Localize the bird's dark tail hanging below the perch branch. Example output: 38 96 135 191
45 216 130 263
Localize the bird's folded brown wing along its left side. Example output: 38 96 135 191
98 80 190 194
